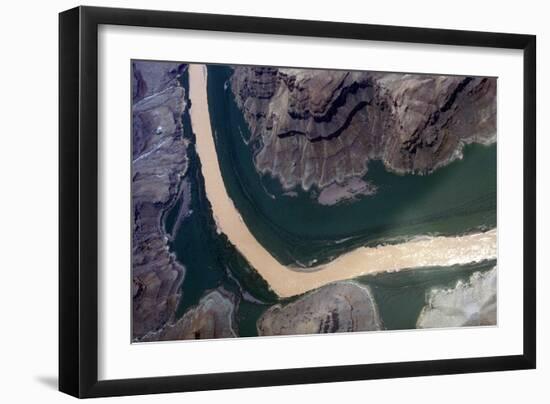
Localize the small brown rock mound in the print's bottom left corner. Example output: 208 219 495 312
141 287 237 342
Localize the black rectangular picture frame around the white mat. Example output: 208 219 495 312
59 7 536 398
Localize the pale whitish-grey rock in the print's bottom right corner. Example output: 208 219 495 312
416 267 497 328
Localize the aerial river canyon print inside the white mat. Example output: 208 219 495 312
132 60 498 343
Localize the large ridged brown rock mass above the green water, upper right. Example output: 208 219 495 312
231 66 496 202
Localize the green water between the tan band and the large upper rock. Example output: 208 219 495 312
208 66 496 266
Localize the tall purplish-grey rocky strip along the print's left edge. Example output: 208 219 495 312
132 62 188 339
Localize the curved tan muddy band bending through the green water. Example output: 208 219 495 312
189 64 497 297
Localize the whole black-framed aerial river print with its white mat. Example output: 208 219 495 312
59 7 536 397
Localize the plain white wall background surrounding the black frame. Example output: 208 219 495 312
0 0 550 403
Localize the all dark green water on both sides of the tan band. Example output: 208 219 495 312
165 66 496 336
